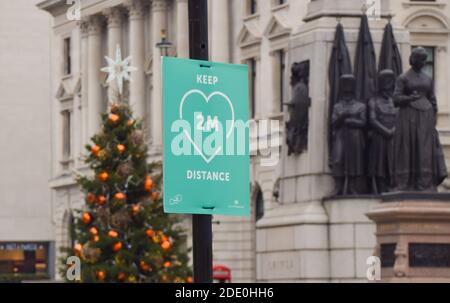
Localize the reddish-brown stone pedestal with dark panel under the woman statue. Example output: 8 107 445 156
367 193 450 282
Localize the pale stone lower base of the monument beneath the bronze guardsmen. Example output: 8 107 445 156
256 196 380 283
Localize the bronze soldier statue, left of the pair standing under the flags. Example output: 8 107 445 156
331 74 367 195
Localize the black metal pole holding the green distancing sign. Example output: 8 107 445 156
188 0 212 283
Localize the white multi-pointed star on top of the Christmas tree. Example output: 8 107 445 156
100 45 137 95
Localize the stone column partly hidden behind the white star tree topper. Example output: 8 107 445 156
103 7 122 102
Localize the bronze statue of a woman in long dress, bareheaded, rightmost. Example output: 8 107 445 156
394 47 447 191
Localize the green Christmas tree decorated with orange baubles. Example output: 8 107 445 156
62 103 192 282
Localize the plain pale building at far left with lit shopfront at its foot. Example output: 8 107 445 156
0 0 54 280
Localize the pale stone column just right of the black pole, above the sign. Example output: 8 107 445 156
211 0 230 62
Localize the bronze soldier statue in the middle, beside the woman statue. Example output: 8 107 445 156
368 69 398 194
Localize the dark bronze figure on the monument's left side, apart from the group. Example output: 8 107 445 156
285 61 311 155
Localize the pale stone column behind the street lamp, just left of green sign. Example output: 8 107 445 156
151 0 167 153
